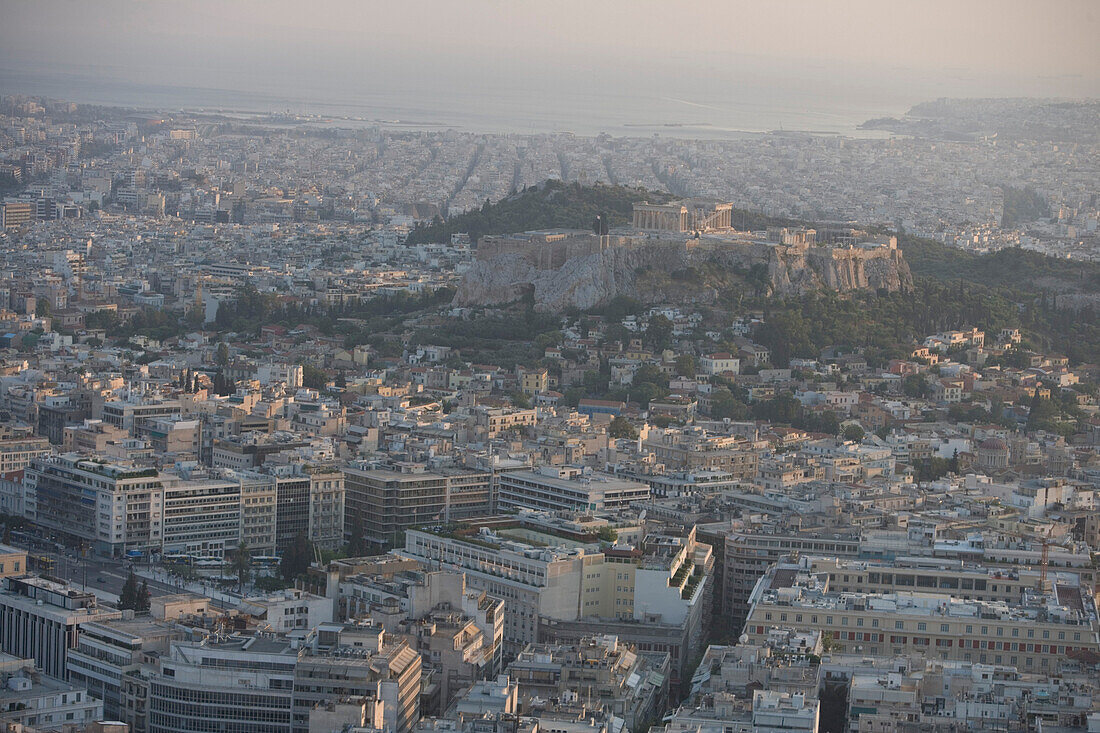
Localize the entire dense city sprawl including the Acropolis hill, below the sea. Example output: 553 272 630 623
0 5 1100 733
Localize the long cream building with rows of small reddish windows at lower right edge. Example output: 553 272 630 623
745 559 1100 672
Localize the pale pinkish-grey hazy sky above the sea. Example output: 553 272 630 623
0 0 1100 129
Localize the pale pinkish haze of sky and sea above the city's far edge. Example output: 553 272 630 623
0 1 1100 133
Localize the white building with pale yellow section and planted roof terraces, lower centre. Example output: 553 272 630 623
397 524 714 669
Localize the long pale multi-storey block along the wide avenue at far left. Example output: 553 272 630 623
24 453 344 557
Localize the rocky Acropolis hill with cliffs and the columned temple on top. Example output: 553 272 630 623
454 199 912 311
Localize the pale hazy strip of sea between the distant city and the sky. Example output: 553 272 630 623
0 66 925 140
